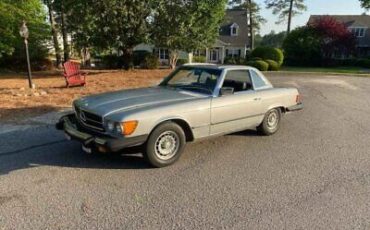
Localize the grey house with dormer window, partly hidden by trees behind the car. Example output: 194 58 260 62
134 9 249 64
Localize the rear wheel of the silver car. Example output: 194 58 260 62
257 108 281 136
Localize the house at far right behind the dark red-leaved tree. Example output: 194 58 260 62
308 15 370 56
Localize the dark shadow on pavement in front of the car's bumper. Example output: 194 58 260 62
0 140 151 175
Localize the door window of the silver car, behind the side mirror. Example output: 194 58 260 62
222 70 253 92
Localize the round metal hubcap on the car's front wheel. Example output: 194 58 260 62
155 131 180 160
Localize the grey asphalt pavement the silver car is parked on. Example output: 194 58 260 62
0 75 370 229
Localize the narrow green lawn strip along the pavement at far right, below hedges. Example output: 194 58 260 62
281 66 370 74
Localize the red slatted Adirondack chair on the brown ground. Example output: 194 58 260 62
63 61 87 87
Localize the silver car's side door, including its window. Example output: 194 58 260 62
210 69 263 135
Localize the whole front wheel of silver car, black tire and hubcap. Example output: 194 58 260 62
144 122 186 168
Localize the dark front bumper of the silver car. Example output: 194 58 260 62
56 114 148 152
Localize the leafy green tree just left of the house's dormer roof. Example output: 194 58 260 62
151 0 226 68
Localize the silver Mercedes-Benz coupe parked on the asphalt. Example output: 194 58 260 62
56 64 303 167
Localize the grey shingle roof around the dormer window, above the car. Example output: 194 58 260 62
218 9 248 47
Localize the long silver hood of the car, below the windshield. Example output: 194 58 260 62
75 87 205 116
